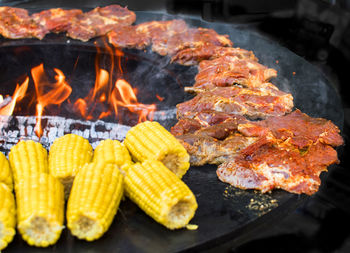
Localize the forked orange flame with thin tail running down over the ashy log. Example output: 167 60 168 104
31 64 72 137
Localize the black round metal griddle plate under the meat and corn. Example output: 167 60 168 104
0 12 344 253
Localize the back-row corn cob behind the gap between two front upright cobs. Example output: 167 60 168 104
49 134 93 197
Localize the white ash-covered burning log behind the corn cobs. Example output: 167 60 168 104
0 108 176 154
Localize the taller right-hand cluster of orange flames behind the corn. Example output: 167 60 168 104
73 42 154 122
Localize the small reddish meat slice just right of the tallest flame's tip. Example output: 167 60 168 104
108 26 151 49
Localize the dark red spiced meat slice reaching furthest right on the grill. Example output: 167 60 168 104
238 110 344 149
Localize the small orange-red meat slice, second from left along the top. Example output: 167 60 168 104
32 8 83 33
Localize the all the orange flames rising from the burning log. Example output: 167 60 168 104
0 43 158 137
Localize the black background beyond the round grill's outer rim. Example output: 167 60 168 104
0 0 350 253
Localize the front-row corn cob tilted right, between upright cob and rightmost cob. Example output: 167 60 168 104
67 163 123 241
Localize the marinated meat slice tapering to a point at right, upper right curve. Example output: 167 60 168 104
194 55 277 89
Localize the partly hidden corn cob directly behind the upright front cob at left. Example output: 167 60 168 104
9 140 49 184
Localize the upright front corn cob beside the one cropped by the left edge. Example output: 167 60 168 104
15 173 64 247
